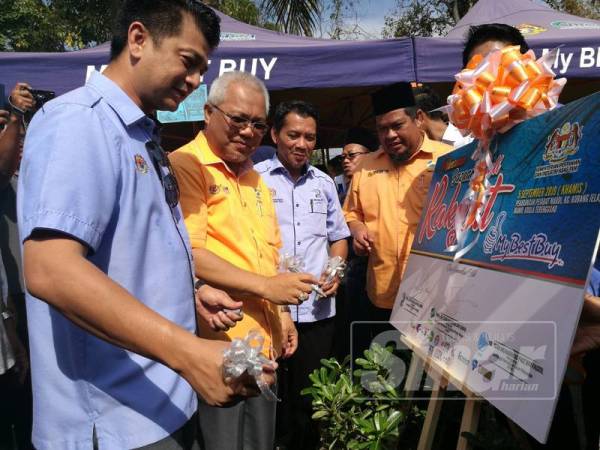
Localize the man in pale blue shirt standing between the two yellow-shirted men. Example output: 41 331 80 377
254 101 350 449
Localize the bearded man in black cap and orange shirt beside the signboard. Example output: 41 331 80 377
344 83 452 342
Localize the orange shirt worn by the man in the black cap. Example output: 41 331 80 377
344 136 452 309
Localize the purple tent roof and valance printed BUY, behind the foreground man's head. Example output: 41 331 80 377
0 6 415 94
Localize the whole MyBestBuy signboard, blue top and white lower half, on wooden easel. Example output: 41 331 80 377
391 93 600 442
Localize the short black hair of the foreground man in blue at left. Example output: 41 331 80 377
110 0 221 61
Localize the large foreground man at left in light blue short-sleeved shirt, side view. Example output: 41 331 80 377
18 0 272 450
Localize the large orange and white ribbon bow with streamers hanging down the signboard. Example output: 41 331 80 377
438 45 567 261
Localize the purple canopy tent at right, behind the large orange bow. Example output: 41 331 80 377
413 0 600 102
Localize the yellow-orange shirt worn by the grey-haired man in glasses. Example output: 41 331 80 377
169 133 282 356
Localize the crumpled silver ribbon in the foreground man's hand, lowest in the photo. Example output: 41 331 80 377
223 330 279 402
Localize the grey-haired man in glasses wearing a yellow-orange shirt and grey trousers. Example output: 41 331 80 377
170 72 318 450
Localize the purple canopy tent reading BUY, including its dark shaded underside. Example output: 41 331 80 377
0 12 415 147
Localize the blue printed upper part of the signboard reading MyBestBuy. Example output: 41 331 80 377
412 93 600 286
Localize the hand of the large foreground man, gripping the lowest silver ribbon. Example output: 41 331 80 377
181 338 277 406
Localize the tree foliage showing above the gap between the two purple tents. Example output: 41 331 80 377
382 0 477 38
